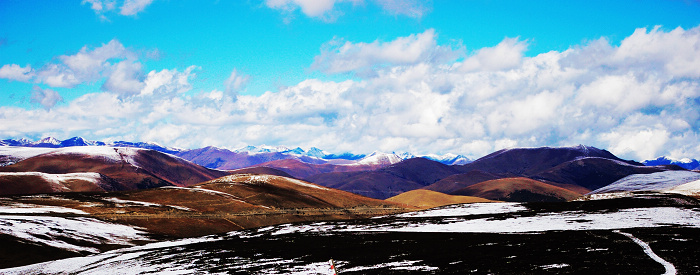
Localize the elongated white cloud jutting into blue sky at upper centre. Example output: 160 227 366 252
311 29 461 74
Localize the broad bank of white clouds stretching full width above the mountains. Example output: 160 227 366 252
0 27 700 160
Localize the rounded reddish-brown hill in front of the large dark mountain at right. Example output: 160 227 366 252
453 177 581 202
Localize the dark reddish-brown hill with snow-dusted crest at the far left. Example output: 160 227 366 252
0 147 228 194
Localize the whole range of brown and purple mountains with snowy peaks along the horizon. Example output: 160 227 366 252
0 137 696 204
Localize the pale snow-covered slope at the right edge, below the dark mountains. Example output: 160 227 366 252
589 171 700 194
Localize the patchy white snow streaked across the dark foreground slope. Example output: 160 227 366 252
0 198 700 274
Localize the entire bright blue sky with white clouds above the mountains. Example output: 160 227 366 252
0 0 700 160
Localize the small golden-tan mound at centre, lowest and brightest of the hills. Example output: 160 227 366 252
386 189 493 208
